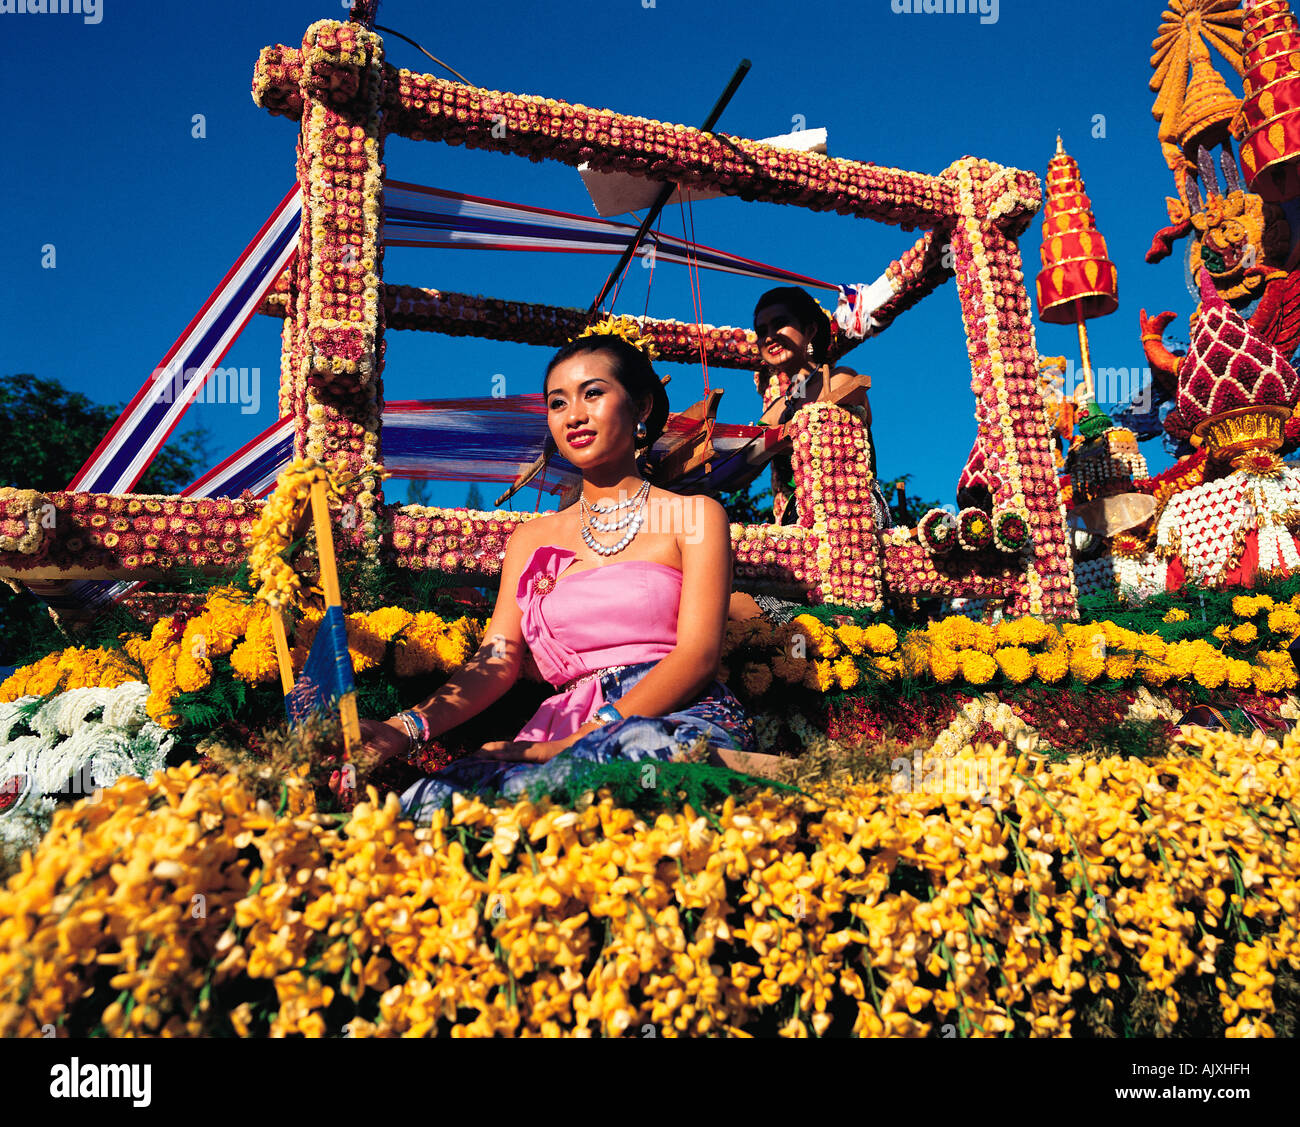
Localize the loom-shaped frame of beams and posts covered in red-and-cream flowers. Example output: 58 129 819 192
0 19 1075 616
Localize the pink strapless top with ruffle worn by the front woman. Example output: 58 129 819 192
515 545 681 741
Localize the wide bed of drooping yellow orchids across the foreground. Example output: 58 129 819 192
0 731 1300 1037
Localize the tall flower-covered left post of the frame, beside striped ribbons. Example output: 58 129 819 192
286 19 384 554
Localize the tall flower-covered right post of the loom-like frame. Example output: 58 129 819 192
945 157 1078 617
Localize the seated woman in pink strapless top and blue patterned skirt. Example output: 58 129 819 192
351 322 757 819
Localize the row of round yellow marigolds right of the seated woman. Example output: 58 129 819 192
723 608 1300 698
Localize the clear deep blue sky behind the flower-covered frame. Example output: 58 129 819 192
0 0 1211 511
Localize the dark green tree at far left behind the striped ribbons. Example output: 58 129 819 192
0 372 207 666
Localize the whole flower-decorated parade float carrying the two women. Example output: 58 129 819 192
0 0 1300 1037
